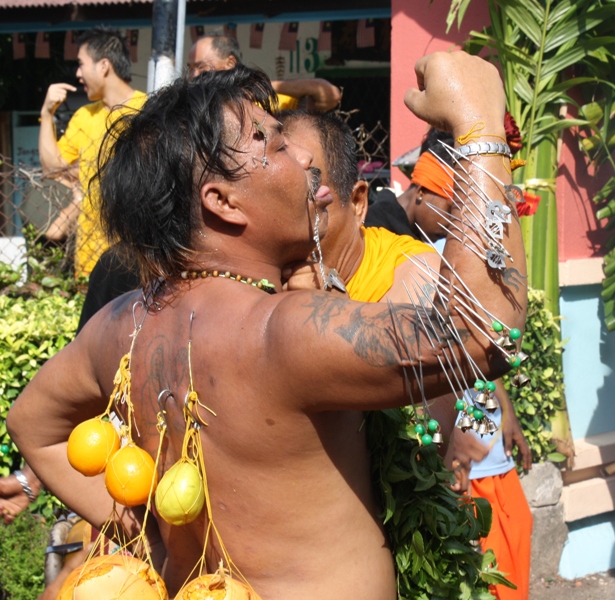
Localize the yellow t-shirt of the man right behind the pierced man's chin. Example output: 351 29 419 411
346 227 435 302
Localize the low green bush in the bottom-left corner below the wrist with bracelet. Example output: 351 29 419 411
0 512 49 600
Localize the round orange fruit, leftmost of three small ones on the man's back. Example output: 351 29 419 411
66 418 120 477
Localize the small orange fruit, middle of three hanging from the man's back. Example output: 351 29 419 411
105 443 158 506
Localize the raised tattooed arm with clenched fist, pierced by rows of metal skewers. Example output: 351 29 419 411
271 52 527 410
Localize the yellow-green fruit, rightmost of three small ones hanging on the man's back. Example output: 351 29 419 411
156 460 205 525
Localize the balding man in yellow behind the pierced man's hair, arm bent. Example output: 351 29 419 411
188 35 342 112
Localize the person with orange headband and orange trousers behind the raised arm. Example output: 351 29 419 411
366 129 532 600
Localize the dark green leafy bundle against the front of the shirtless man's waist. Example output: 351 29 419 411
367 407 508 600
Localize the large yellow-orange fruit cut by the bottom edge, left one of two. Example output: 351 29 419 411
56 554 169 600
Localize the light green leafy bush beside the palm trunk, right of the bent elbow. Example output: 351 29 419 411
504 289 566 462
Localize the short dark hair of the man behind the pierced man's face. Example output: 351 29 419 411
276 110 359 206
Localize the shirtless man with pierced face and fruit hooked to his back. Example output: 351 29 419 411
9 55 525 600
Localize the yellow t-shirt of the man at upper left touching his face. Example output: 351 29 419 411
58 91 147 276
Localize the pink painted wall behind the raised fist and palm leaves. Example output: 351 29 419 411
391 0 606 262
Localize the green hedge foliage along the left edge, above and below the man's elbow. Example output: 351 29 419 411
0 237 84 600
